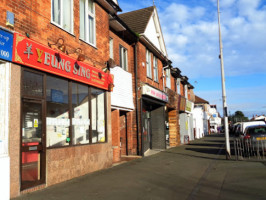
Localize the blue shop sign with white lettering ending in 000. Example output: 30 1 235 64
0 29 13 61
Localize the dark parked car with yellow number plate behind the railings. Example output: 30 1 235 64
242 124 266 151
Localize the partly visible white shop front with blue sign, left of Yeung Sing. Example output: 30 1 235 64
0 27 13 200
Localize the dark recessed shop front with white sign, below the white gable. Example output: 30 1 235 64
141 85 168 155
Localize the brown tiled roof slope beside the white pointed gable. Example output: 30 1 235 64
118 6 154 34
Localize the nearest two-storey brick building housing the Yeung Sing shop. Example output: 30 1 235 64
0 0 120 197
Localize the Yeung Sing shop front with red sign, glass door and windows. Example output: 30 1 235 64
11 34 112 194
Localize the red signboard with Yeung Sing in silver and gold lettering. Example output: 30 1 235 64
13 33 113 90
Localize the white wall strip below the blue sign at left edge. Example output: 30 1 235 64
0 61 10 200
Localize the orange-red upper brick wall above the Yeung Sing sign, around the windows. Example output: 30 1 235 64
0 0 109 68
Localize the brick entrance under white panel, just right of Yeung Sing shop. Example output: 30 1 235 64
110 66 136 162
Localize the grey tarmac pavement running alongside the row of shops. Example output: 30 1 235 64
16 134 266 200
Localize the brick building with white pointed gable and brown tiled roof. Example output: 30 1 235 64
119 7 170 155
